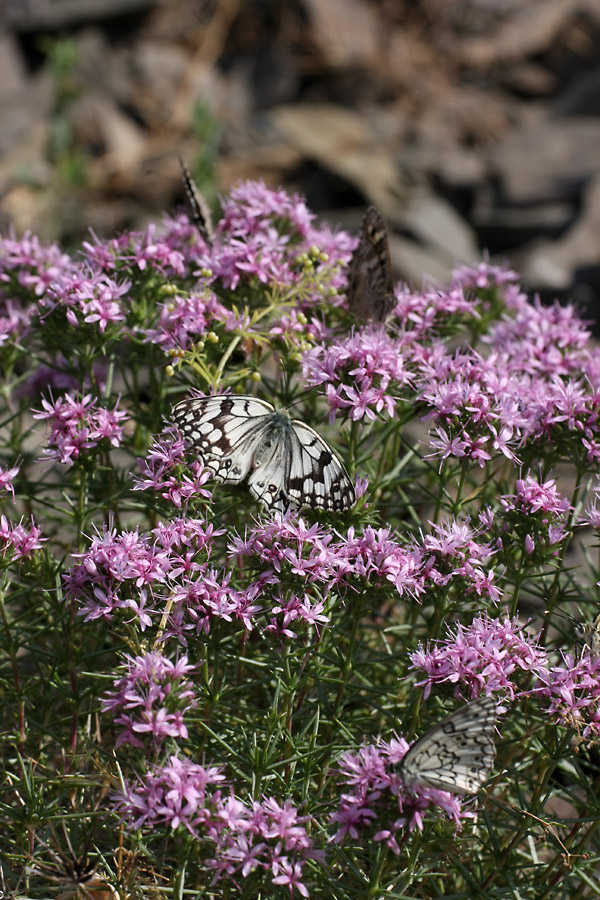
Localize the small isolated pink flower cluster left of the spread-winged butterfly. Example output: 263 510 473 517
33 394 129 466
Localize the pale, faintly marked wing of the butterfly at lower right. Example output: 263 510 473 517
398 697 497 794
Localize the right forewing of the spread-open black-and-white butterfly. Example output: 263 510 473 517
286 419 356 512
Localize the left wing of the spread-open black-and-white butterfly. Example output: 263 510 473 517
172 395 274 484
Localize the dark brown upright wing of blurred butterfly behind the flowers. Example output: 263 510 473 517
348 206 396 322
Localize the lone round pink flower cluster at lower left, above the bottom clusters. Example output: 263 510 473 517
102 653 198 748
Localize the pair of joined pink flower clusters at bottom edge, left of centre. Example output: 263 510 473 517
119 756 321 897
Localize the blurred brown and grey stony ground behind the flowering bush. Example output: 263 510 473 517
0 0 600 319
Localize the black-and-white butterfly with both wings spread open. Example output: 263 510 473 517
173 394 356 512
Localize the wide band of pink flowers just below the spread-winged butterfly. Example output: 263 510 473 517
65 506 499 646
